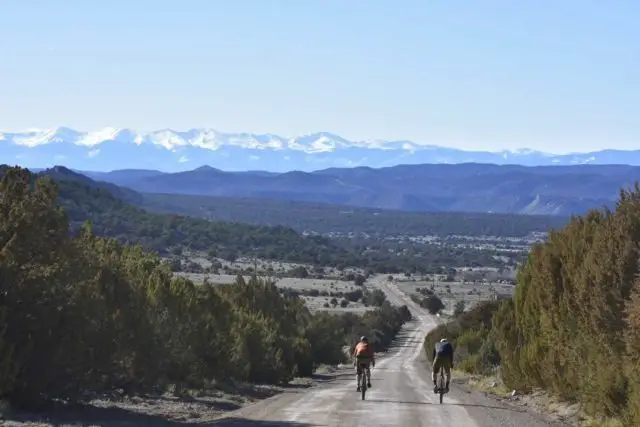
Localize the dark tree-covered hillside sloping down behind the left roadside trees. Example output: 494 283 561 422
18 167 347 264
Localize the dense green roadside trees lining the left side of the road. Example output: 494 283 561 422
0 168 410 406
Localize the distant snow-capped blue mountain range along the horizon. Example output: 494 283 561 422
0 127 640 172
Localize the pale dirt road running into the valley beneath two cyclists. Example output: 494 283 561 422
214 277 565 427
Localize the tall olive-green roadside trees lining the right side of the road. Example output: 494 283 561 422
425 185 640 426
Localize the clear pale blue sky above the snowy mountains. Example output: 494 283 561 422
0 0 640 153
